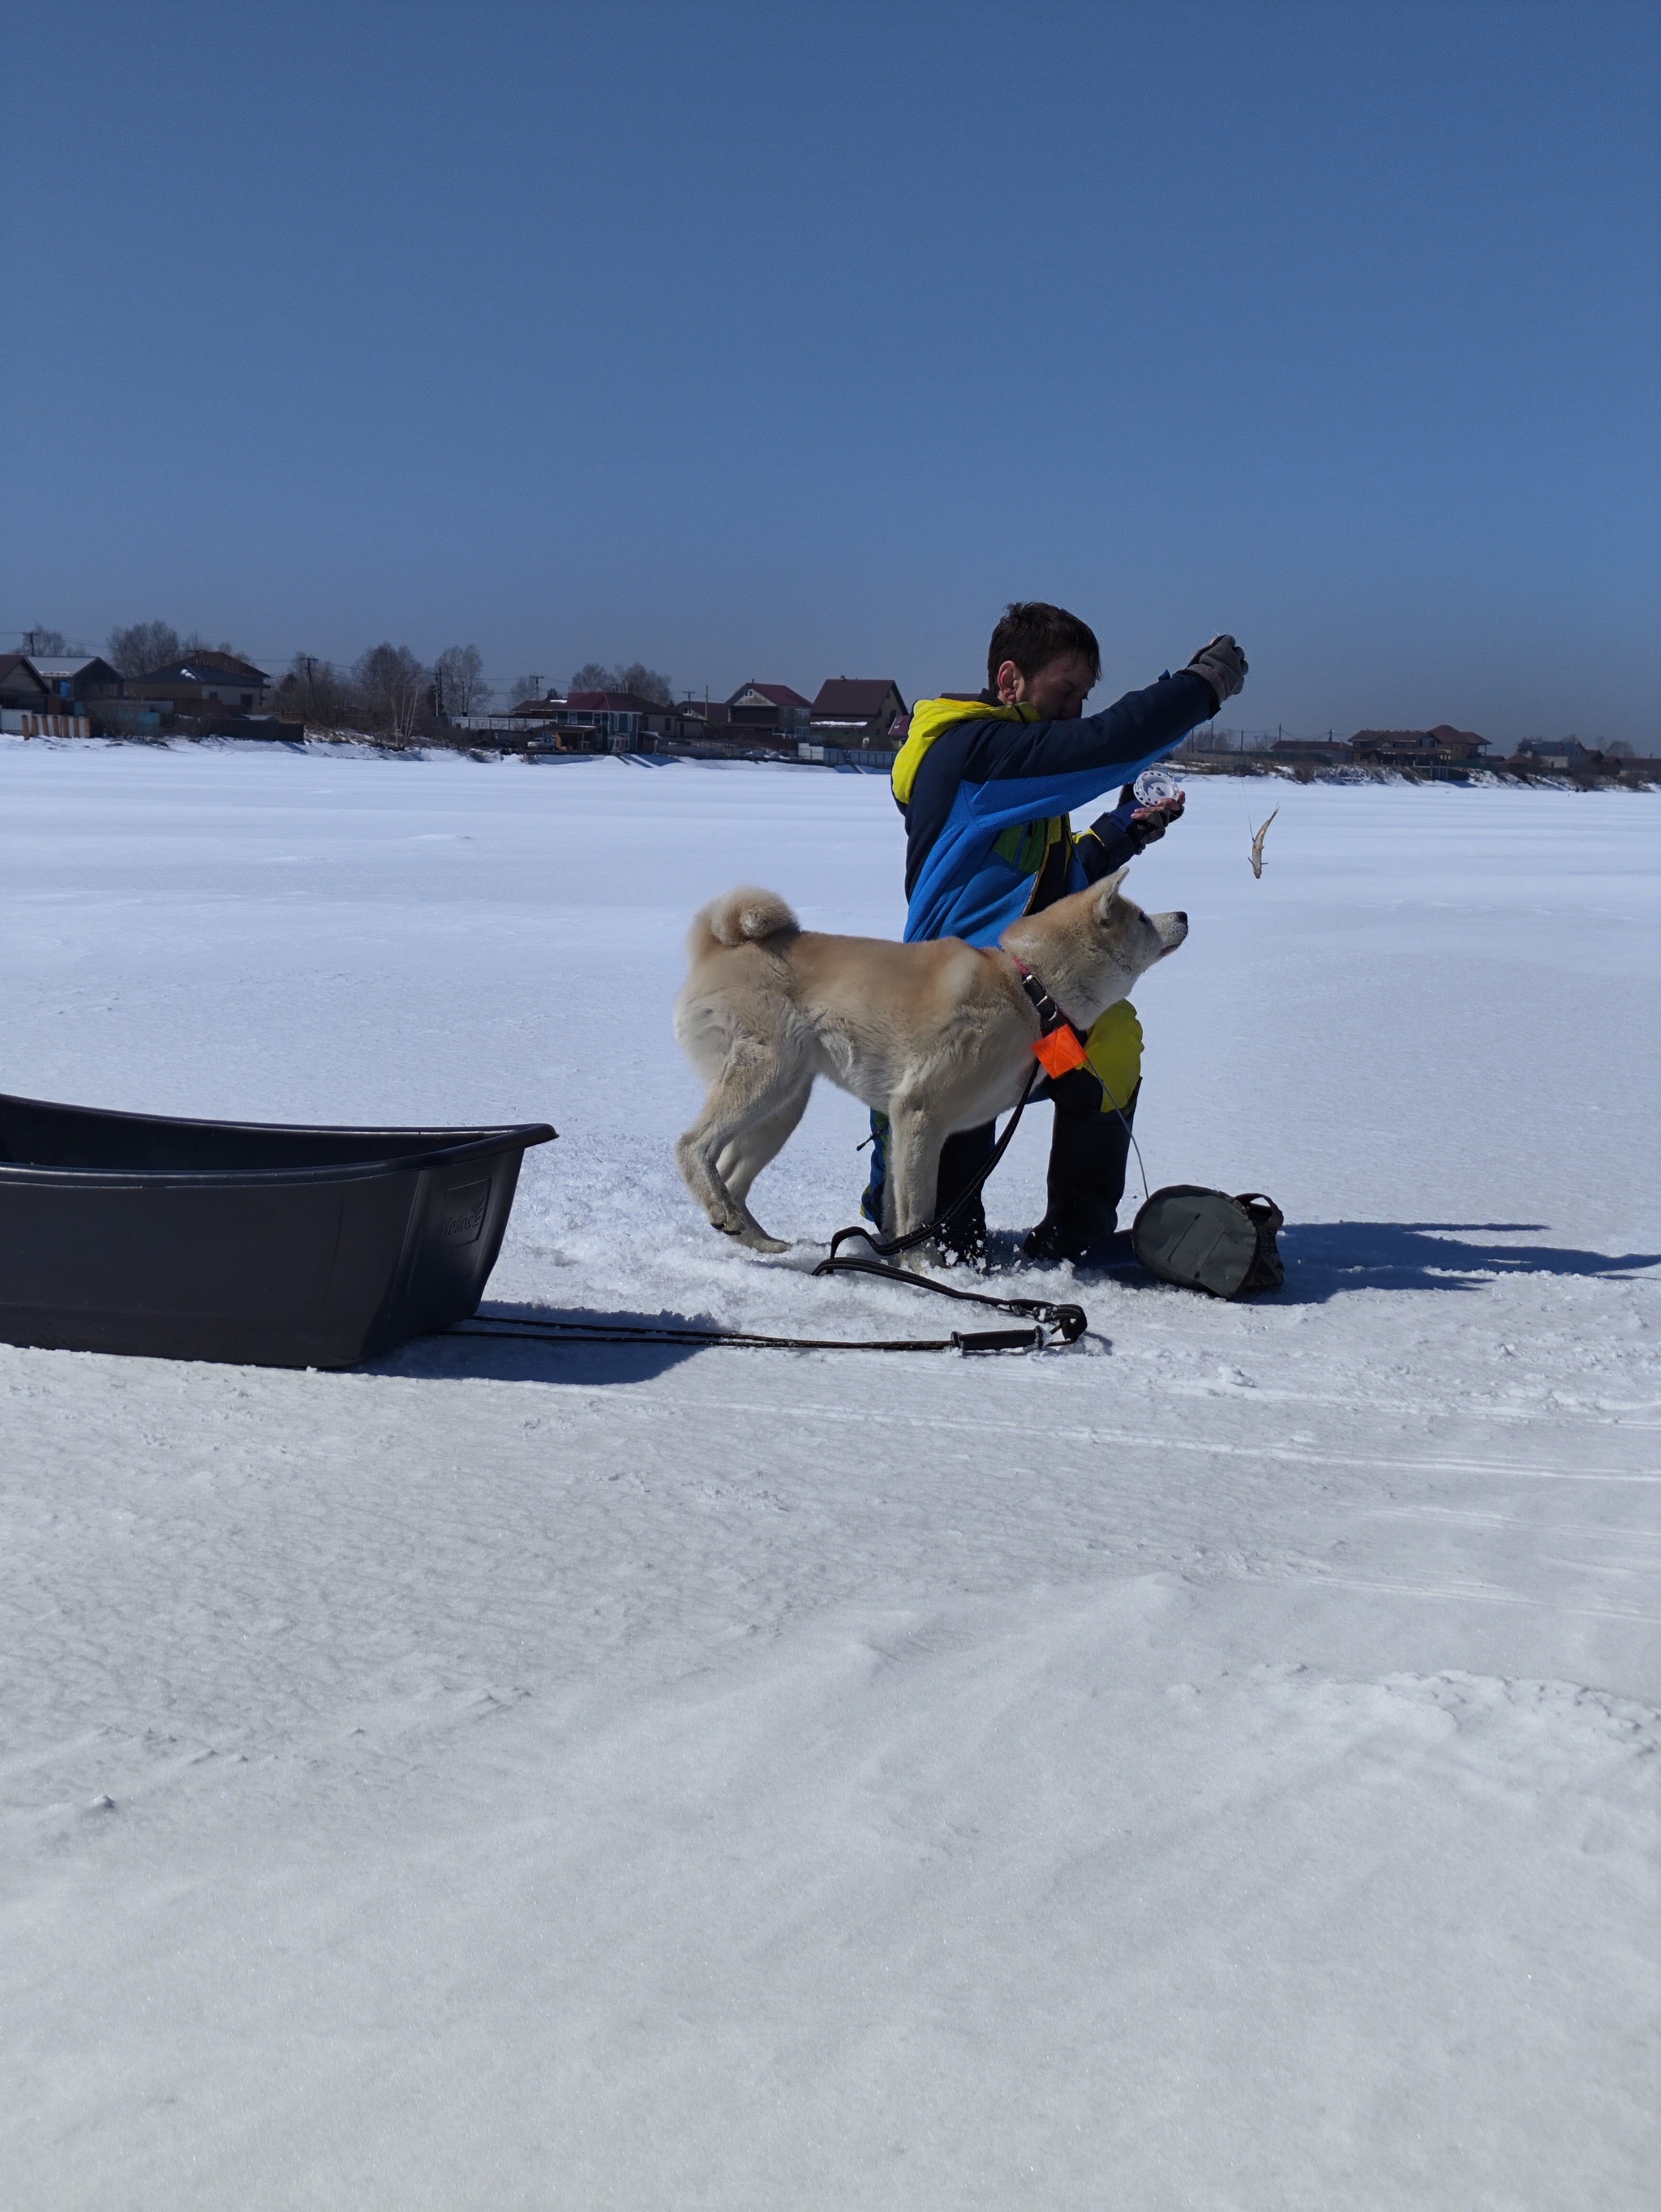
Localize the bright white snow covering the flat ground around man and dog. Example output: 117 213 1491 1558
0 744 1661 2212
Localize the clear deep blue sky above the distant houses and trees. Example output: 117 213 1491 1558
0 0 1661 750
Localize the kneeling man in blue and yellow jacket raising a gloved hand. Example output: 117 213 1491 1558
865 599 1245 1261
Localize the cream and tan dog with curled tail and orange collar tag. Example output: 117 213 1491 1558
675 869 1187 1252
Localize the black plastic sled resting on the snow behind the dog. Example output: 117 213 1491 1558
0 1093 555 1367
